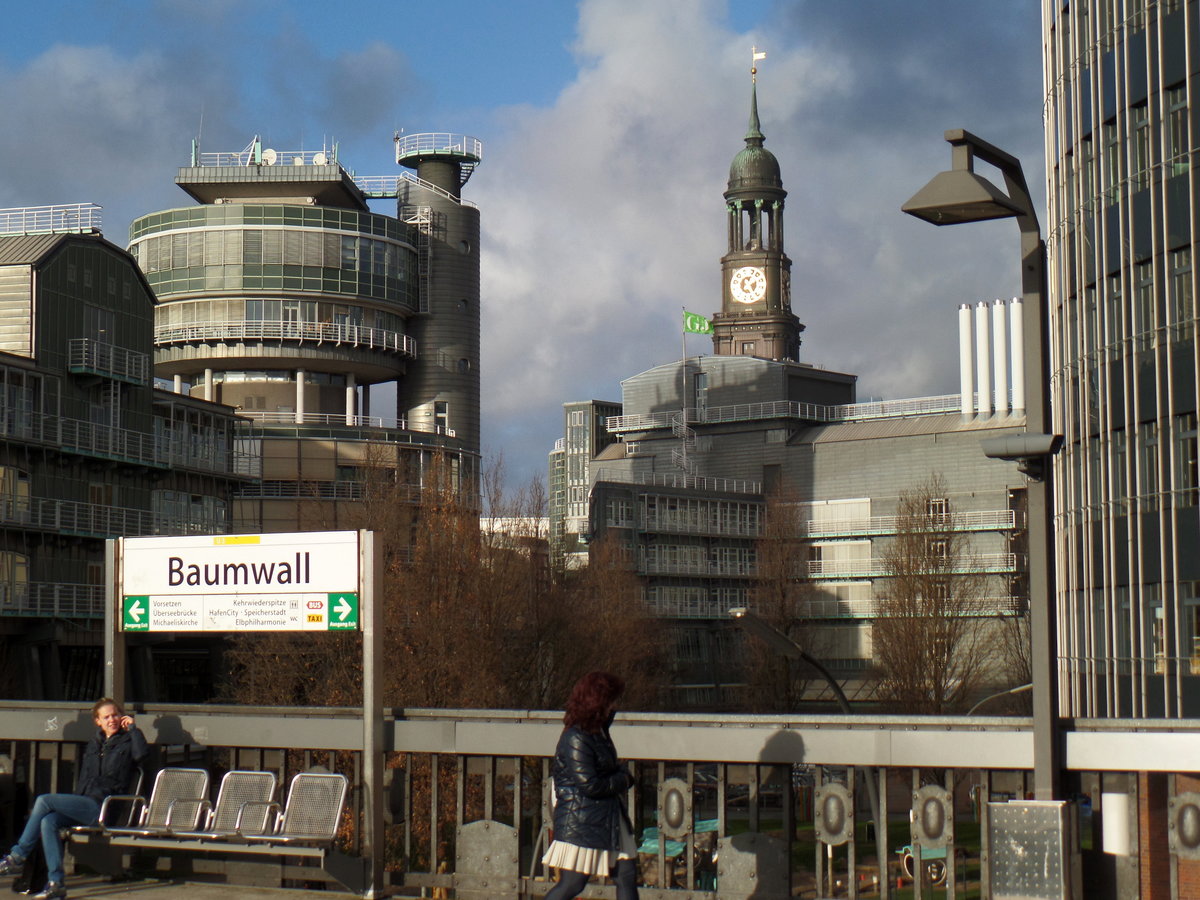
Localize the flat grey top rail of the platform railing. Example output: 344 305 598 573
0 701 1200 772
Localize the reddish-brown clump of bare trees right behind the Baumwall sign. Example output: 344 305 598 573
229 458 665 708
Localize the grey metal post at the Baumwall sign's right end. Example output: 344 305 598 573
359 530 386 898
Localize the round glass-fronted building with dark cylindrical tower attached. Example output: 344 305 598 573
130 134 482 532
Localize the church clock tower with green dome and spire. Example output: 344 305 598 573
713 53 804 360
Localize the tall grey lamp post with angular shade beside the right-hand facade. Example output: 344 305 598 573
900 128 1062 800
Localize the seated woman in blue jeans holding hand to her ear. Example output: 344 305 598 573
0 697 149 900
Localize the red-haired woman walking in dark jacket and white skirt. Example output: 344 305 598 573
541 672 637 900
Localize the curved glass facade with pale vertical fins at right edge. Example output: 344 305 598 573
1043 0 1200 718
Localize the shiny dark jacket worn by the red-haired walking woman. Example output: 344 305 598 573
552 726 634 850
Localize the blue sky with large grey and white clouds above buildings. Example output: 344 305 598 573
0 0 1045 494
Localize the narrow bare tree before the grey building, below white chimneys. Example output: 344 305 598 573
872 475 989 714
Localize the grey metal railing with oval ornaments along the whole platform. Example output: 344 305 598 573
0 702 1200 900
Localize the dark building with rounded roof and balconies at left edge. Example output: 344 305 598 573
0 204 253 700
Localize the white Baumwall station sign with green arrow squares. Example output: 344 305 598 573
119 532 359 631
